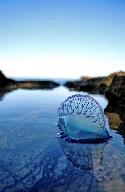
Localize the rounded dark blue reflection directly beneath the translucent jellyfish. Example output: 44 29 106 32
58 138 107 170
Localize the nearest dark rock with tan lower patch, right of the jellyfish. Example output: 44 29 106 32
105 76 125 136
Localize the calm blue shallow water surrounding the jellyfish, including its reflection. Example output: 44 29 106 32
0 87 125 192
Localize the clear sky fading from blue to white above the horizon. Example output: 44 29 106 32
0 0 125 78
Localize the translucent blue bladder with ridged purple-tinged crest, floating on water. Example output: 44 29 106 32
58 94 110 140
